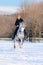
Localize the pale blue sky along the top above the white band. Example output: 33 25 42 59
0 0 43 7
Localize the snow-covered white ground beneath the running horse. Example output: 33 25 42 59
0 40 43 65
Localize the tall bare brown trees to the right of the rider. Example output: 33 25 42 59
21 2 43 37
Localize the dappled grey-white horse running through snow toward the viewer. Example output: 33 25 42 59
14 22 25 48
